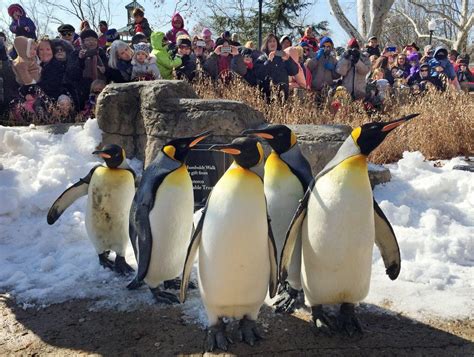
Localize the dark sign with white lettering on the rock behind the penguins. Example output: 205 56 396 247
187 144 232 210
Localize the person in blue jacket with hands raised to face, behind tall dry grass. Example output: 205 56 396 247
306 37 339 95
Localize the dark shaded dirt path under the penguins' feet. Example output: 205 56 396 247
0 294 474 356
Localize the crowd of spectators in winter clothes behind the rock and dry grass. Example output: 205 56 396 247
0 4 474 121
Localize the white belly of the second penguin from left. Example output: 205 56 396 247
144 165 194 288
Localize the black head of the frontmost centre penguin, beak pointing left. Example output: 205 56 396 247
209 137 264 169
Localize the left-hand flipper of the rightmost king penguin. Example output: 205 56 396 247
279 180 316 282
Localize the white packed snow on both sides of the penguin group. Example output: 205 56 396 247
0 120 474 323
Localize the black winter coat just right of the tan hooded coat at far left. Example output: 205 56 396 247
38 57 67 100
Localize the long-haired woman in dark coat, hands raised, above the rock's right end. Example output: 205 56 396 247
255 34 299 102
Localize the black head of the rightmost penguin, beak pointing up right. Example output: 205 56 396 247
351 114 420 156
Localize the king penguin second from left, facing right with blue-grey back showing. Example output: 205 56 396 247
128 132 210 304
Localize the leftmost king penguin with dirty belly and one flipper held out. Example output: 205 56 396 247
47 144 135 275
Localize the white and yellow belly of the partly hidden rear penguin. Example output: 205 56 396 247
264 152 304 290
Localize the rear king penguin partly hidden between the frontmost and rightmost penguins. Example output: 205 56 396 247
242 125 313 313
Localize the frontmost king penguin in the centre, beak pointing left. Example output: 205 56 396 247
180 137 278 351
